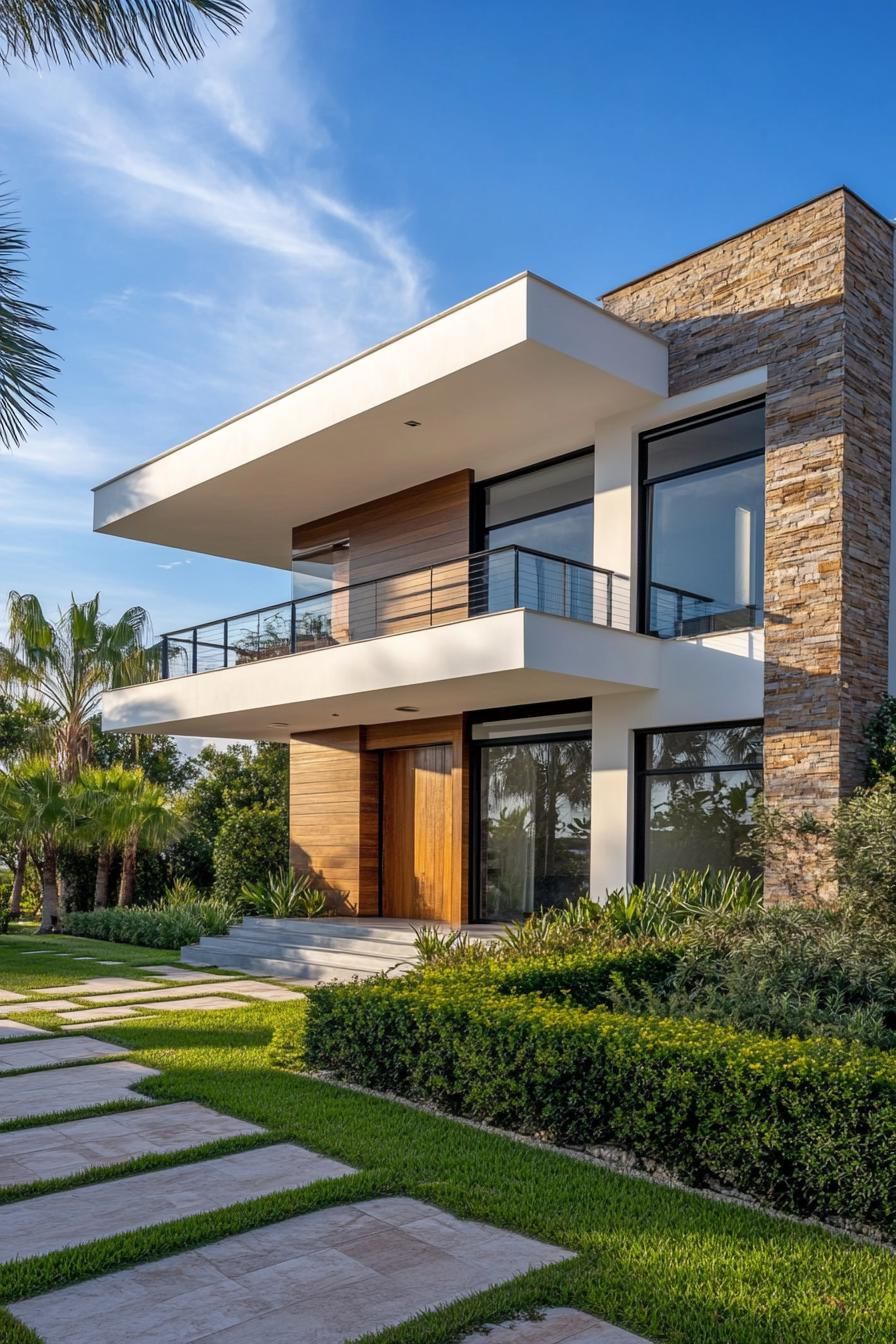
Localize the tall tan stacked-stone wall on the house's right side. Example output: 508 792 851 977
603 190 893 894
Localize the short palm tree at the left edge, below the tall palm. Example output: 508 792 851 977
0 757 79 933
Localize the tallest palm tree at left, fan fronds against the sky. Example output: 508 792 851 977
0 593 157 781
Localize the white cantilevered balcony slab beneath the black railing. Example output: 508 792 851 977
102 609 661 742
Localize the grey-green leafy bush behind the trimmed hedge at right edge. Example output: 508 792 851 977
603 906 896 1048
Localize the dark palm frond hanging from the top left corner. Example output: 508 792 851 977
0 0 247 71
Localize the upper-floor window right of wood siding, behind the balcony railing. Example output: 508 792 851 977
474 449 595 621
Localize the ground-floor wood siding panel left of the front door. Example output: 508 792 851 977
289 727 379 915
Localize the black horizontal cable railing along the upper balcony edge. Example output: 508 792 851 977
161 546 630 677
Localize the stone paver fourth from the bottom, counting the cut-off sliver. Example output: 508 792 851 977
0 1101 263 1185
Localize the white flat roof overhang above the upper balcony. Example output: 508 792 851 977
94 273 668 569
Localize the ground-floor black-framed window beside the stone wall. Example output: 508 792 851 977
638 723 762 880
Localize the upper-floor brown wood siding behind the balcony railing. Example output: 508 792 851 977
293 470 473 640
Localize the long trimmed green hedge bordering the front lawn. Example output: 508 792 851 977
303 973 896 1232
